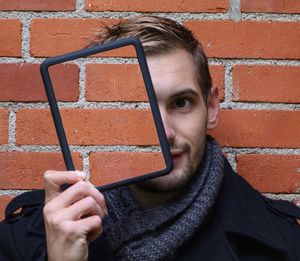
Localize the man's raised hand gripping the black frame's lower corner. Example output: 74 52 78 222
44 171 107 261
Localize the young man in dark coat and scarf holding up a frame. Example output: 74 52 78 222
0 16 300 261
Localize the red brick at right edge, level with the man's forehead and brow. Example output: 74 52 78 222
233 65 300 103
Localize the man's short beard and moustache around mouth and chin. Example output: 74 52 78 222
137 140 204 193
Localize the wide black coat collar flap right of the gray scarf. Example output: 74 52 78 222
217 160 284 251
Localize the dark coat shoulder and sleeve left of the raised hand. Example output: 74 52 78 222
0 191 46 261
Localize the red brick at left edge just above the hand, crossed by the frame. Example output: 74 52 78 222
0 152 82 189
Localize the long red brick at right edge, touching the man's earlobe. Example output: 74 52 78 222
210 110 300 148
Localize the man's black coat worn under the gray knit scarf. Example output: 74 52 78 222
0 159 300 261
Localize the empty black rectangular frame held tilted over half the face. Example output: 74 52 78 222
40 37 173 191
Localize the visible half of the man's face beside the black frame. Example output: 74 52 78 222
140 49 218 192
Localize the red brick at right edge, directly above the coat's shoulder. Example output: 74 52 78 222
237 154 300 193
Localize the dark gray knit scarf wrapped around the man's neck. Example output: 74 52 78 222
103 138 224 261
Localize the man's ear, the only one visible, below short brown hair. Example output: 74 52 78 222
207 86 220 130
